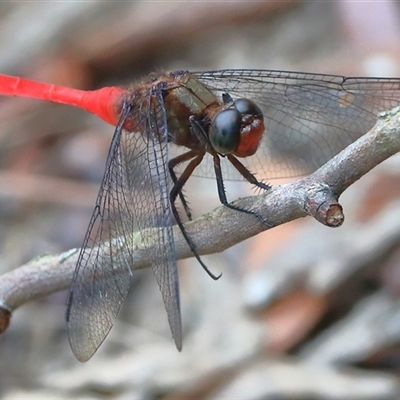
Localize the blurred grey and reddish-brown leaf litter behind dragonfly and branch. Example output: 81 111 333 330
0 1 400 399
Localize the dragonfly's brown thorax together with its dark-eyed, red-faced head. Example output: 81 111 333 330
163 72 264 157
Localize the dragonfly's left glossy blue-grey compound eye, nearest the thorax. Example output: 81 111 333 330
210 108 242 154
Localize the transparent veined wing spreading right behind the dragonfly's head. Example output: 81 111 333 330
190 70 400 179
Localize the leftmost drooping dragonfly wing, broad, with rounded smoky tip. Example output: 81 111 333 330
66 107 141 362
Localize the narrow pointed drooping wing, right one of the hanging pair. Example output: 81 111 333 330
136 90 182 350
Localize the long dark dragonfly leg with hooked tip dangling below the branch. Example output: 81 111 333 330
169 151 222 280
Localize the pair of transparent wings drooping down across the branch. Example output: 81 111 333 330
66 94 181 361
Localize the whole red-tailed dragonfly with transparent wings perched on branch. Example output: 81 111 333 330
0 69 400 362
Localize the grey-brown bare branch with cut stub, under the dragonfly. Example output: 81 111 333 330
0 107 400 333
